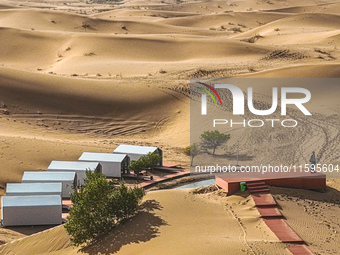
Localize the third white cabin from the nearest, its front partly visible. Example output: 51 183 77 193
22 171 77 198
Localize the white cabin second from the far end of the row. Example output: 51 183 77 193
78 152 130 178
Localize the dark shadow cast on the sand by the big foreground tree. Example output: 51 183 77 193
81 200 168 255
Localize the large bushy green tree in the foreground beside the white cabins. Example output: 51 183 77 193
64 171 144 246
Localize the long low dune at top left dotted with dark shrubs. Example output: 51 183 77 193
0 10 209 34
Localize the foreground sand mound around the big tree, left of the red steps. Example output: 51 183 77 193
0 190 283 255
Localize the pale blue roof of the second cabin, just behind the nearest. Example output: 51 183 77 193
6 183 62 193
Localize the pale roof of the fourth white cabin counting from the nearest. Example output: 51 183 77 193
47 160 99 171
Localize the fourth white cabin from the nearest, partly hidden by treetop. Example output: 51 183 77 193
47 160 101 187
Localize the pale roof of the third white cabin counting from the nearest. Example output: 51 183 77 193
22 171 76 182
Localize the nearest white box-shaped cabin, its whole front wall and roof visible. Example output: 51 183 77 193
1 195 62 227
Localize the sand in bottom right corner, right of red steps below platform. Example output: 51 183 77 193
271 179 340 254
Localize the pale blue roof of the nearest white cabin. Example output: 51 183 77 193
1 195 61 207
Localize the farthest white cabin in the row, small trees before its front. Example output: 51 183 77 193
113 144 163 166
